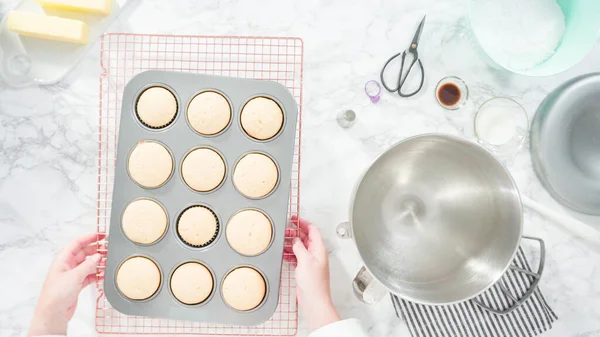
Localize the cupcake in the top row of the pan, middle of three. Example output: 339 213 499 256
187 91 231 136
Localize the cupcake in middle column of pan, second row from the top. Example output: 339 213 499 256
181 148 225 192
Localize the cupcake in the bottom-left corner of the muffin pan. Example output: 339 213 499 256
116 256 160 301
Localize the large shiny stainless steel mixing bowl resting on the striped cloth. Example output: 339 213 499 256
338 134 523 304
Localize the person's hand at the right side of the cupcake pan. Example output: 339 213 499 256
284 217 340 332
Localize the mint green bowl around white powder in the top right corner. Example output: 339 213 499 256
469 0 600 76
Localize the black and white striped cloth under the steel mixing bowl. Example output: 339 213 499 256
391 248 558 337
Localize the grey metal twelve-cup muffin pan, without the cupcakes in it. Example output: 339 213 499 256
104 71 298 325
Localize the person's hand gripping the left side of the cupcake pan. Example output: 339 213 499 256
29 233 104 336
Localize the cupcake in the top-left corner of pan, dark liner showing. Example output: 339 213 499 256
135 87 177 129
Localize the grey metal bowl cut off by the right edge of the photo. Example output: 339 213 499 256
531 73 600 215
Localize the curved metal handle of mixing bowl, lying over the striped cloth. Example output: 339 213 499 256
473 236 546 315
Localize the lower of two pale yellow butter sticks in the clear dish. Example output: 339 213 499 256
7 12 88 44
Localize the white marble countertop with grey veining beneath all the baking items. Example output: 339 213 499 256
0 0 600 337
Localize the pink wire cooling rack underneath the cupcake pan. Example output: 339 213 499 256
96 34 303 336
